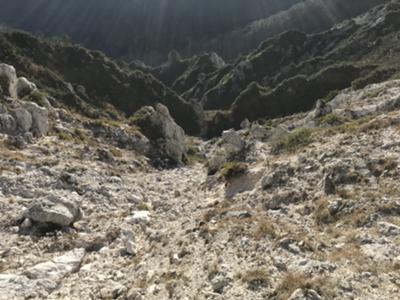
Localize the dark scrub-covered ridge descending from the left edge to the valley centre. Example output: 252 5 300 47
0 31 202 134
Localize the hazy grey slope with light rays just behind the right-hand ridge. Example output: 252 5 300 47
199 0 390 58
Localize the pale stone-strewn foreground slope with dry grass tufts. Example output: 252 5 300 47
0 67 400 300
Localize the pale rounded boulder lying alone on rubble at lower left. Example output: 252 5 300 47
24 195 82 226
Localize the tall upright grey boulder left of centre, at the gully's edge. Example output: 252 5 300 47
132 104 187 166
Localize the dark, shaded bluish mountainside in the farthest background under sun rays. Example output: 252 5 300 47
0 0 301 63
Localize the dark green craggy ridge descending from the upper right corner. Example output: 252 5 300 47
190 1 400 135
